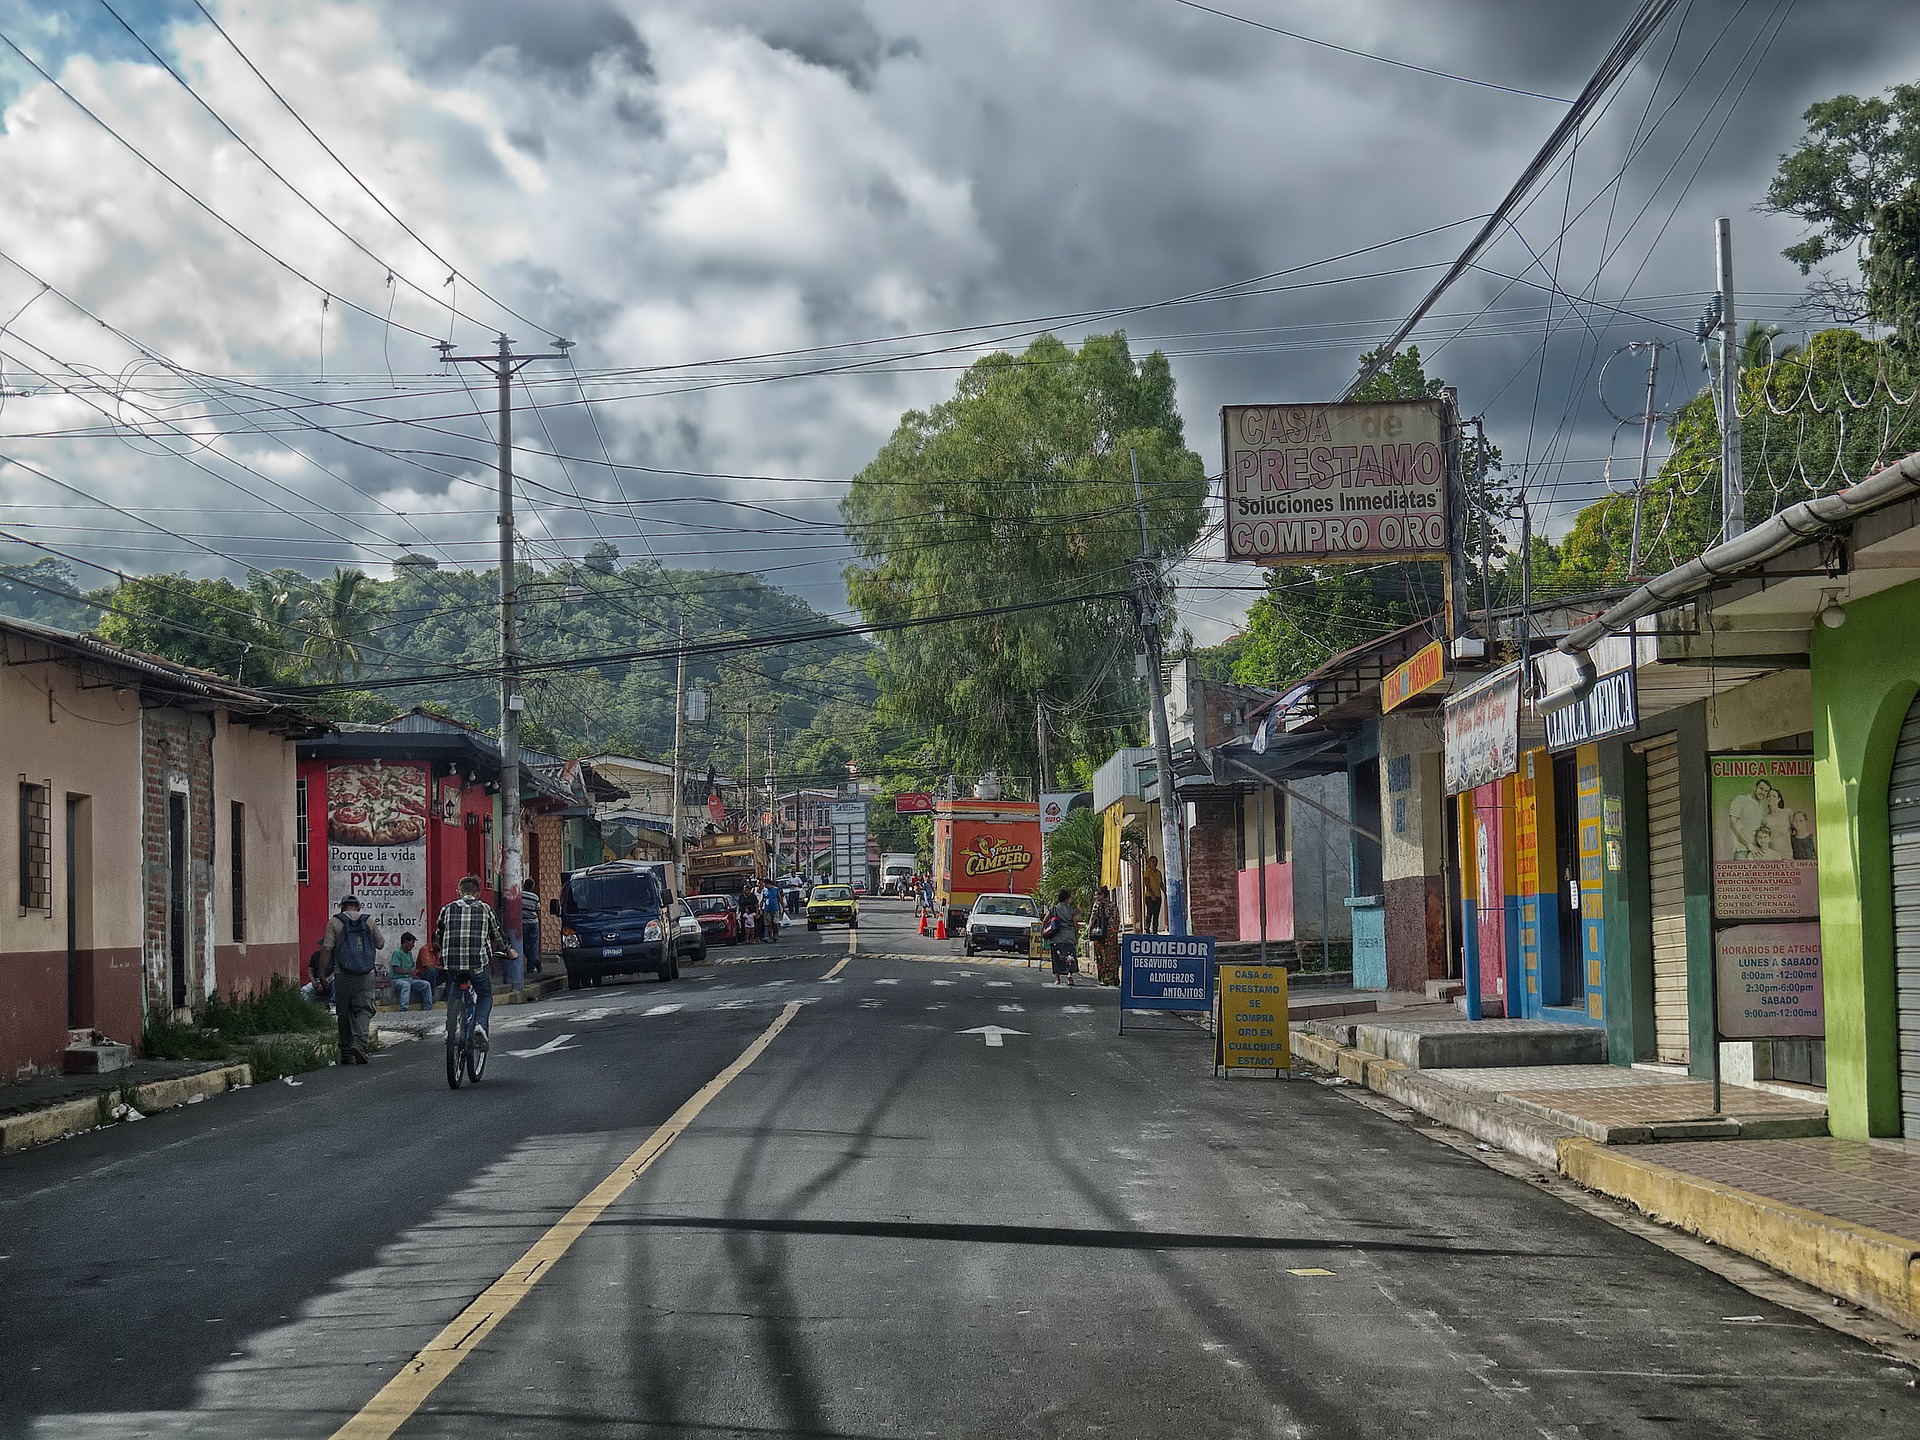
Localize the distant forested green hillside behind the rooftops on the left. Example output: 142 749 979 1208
0 557 889 783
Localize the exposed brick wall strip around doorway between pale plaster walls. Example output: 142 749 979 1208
140 708 216 1016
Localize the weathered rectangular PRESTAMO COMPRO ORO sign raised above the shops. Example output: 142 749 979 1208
1221 399 1448 564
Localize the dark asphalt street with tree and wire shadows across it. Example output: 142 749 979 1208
0 902 1920 1440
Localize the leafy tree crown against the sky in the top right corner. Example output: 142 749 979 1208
1761 84 1920 275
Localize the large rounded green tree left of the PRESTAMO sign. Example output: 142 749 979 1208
841 334 1208 791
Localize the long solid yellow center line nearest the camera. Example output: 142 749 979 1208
334 1006 806 1440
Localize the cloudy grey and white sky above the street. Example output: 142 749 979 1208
0 0 1920 639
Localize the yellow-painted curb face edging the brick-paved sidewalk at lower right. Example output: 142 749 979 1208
1559 1139 1920 1329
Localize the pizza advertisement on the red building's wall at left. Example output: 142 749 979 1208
326 764 428 948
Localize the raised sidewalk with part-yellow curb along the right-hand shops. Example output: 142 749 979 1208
1292 1021 1920 1331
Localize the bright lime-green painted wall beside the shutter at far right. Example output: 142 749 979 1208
1811 582 1920 1140
